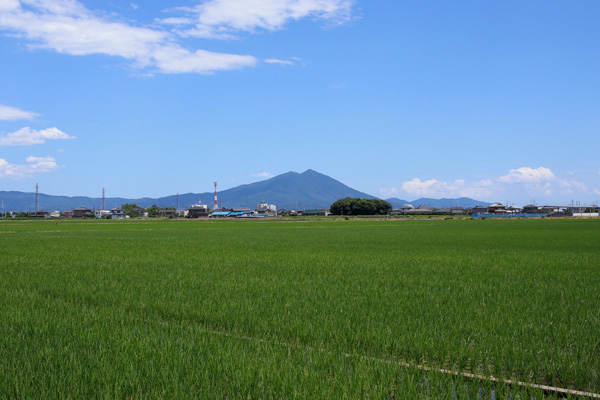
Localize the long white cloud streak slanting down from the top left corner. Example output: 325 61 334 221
0 0 256 74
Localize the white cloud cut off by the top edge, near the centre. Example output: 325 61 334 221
172 0 354 39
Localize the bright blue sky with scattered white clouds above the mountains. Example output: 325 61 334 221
0 0 600 205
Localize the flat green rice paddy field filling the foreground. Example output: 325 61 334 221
0 220 600 399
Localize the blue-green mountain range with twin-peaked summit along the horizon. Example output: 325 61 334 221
0 169 490 211
